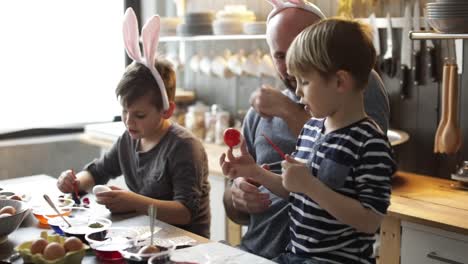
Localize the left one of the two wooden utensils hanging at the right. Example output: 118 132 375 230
434 59 453 153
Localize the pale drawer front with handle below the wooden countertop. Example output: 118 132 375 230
401 222 468 264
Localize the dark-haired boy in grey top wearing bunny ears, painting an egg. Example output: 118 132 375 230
57 9 211 238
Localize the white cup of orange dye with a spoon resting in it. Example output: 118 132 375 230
32 198 75 226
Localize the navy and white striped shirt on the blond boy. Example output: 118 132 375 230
287 118 396 264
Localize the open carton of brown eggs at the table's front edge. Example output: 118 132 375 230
15 231 89 264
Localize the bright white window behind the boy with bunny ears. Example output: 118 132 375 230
0 0 125 133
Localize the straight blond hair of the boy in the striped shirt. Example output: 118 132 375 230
286 18 376 89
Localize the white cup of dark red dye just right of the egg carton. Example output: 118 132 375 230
85 227 138 262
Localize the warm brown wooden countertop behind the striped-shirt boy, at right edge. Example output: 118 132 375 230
388 171 468 235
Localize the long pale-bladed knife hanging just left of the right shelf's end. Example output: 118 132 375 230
400 5 412 99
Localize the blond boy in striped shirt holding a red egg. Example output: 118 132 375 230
222 19 396 263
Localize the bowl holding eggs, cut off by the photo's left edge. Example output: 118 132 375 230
0 199 30 243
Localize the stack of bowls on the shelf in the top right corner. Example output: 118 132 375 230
426 0 468 33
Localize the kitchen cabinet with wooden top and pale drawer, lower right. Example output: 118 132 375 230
379 171 468 264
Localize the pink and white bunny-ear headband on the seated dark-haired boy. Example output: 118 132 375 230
123 7 169 110
